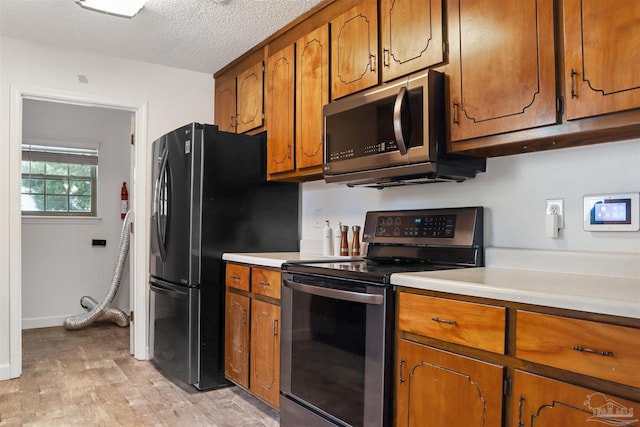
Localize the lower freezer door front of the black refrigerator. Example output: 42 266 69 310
149 280 200 384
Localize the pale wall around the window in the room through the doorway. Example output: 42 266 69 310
22 99 135 329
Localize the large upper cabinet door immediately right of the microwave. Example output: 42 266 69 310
448 0 557 141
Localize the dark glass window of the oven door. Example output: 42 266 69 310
291 292 367 426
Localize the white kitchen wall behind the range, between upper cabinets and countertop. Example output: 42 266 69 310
302 139 640 256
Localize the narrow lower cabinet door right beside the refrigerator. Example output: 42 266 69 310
224 292 249 387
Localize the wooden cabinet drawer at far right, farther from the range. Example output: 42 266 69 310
516 311 640 387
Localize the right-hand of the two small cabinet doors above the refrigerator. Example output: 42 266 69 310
237 61 264 133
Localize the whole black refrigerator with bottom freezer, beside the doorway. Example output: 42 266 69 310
149 123 300 390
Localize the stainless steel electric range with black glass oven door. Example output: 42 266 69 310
280 207 484 427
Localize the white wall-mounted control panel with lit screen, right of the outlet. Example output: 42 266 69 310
584 193 640 231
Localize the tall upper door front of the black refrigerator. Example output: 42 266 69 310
150 124 202 286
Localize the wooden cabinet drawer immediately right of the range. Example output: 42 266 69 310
398 292 506 354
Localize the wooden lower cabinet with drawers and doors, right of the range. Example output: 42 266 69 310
394 288 640 427
